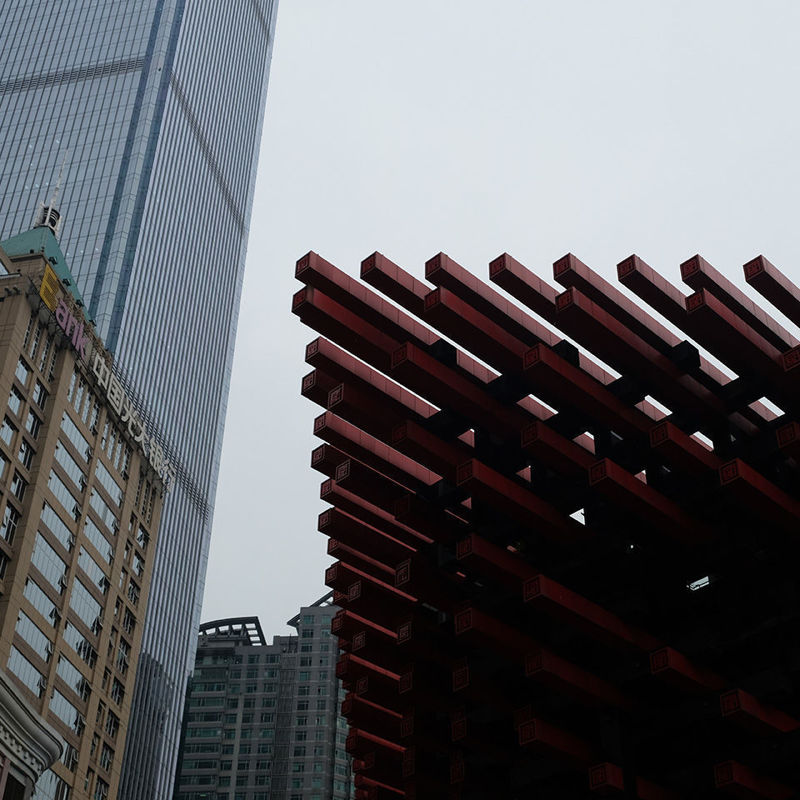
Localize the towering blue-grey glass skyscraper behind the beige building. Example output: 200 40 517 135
0 0 277 800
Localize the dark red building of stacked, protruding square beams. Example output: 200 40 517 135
292 247 800 800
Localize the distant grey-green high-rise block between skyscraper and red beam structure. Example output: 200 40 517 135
175 594 351 800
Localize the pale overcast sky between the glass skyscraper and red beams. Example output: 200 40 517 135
203 0 800 636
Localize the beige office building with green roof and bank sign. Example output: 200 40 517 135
0 210 173 800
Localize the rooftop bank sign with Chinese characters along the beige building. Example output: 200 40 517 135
39 266 176 491
